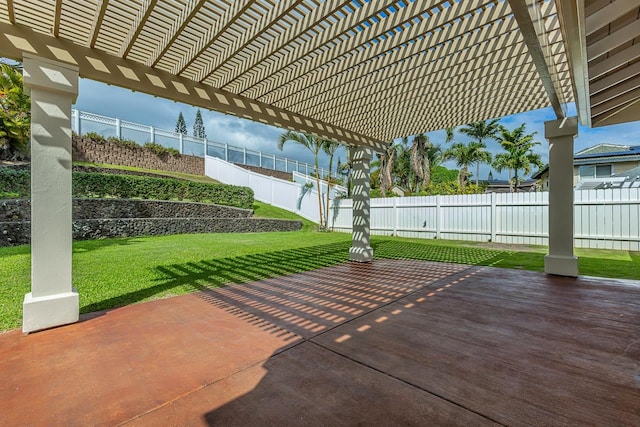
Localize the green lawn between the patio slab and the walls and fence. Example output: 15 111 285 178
0 232 640 330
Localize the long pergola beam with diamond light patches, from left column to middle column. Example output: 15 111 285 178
0 23 388 151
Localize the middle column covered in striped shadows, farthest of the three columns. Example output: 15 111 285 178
349 147 373 262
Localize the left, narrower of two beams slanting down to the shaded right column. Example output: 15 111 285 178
509 0 565 119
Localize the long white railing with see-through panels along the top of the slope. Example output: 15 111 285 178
71 109 328 176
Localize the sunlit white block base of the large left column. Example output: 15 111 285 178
22 289 80 333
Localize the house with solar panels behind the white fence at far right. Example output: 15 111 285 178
531 144 640 191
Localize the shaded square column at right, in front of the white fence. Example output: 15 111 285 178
544 117 578 277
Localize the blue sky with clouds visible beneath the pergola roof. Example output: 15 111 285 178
75 79 640 179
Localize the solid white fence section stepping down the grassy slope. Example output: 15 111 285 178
204 156 326 223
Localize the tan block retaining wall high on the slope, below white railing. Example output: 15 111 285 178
72 135 204 175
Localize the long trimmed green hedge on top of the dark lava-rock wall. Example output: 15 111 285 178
0 168 253 209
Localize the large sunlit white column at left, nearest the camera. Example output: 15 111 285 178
22 54 79 332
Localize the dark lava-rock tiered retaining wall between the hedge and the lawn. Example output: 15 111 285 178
0 199 302 246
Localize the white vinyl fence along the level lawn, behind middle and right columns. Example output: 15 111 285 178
329 188 640 251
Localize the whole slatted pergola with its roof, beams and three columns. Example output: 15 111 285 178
0 0 640 332
